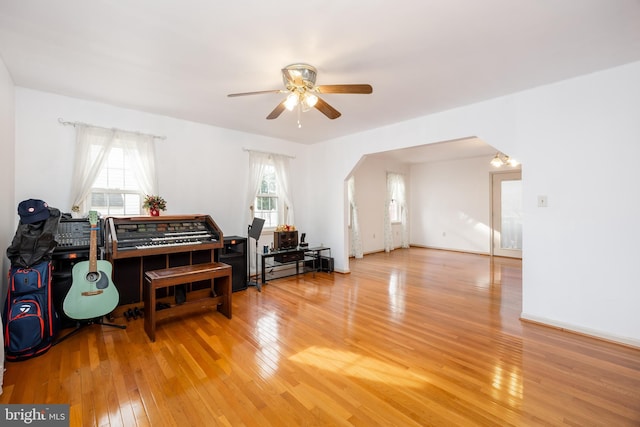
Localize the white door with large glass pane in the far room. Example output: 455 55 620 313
491 171 522 258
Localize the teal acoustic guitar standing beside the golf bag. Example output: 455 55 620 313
62 211 120 320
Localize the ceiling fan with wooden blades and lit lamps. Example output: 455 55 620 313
227 64 373 120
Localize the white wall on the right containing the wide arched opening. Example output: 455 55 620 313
308 62 640 346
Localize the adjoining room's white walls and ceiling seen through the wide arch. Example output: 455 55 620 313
345 137 524 268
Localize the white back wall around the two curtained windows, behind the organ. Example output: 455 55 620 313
10 87 304 236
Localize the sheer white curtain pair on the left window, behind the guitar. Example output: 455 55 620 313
71 124 158 212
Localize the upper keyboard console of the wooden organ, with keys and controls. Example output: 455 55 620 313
106 215 223 259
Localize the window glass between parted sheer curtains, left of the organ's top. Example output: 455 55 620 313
87 143 144 215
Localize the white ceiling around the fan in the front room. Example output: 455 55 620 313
0 0 640 157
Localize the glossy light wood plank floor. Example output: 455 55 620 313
0 248 640 427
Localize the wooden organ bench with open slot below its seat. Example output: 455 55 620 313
143 262 232 342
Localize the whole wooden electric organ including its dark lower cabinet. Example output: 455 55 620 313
105 215 223 305
